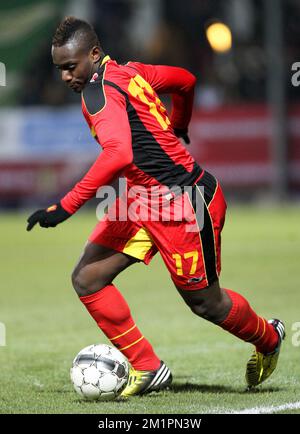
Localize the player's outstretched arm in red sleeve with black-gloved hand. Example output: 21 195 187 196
27 83 133 231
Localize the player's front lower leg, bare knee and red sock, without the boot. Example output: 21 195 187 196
72 243 160 371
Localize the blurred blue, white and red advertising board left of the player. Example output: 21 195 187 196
0 107 96 205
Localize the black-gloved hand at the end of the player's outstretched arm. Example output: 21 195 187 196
26 203 71 231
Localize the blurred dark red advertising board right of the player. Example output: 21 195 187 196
189 105 300 189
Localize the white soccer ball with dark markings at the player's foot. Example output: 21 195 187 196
70 344 129 401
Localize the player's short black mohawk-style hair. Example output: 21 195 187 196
52 17 103 51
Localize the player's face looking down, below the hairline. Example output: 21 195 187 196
52 43 101 92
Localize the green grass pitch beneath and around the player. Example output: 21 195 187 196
0 207 300 414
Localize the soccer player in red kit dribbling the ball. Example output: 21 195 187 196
27 17 285 397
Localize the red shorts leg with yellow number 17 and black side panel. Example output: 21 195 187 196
147 175 226 291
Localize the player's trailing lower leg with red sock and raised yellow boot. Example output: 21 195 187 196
179 282 285 388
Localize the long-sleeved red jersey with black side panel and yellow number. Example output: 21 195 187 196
61 56 202 213
